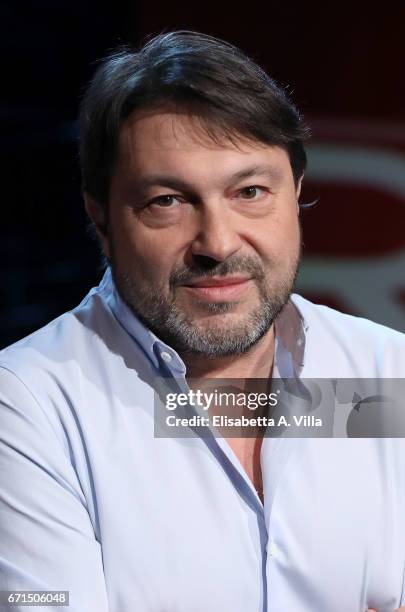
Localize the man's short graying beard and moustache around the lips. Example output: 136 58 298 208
111 250 299 357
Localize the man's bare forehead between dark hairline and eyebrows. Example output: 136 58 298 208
117 110 292 176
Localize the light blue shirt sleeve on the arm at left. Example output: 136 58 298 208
0 367 108 612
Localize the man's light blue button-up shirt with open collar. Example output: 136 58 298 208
0 271 405 612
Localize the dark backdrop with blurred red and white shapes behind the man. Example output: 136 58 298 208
0 0 405 347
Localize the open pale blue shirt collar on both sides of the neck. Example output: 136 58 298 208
97 268 308 378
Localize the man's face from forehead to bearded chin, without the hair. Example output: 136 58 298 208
94 111 300 356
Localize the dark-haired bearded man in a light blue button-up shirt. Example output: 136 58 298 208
0 32 405 612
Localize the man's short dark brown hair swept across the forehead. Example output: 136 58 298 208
80 31 309 206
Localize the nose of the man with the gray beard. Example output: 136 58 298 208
191 201 242 261
